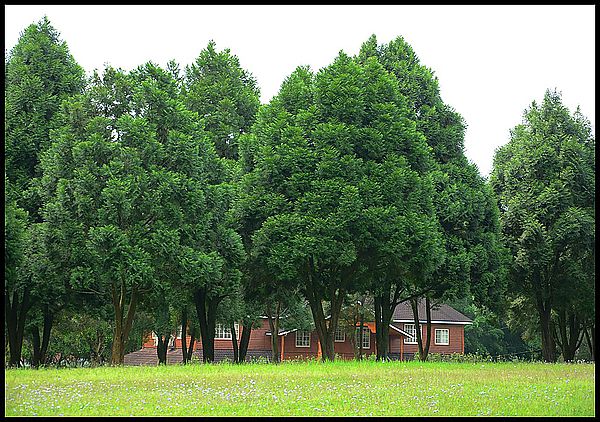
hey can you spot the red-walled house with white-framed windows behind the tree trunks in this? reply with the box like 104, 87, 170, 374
125, 301, 472, 365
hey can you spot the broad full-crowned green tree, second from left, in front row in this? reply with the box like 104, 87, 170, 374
38, 63, 225, 364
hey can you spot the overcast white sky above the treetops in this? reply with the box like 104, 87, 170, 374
4, 5, 596, 176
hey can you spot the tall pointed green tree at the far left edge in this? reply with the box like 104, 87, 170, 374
4, 17, 85, 365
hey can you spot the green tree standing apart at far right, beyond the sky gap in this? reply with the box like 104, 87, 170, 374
490, 90, 595, 362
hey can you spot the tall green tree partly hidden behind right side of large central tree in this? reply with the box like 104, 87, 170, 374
358, 35, 507, 359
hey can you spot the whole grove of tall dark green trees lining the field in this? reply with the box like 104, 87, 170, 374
4, 17, 595, 367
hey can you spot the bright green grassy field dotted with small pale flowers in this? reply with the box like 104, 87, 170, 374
4, 361, 596, 416
